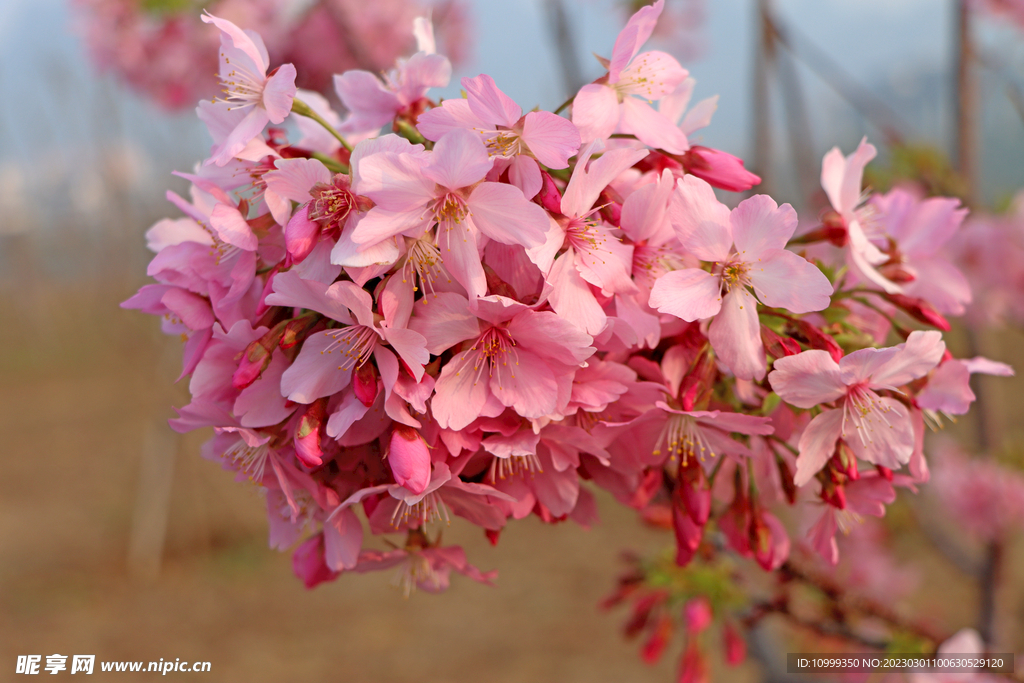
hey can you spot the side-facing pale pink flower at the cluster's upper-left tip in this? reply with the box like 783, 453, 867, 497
203, 14, 295, 166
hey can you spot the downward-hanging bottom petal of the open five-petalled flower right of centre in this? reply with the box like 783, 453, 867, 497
708, 287, 767, 381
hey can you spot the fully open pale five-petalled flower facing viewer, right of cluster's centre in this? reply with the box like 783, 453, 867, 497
650, 176, 833, 380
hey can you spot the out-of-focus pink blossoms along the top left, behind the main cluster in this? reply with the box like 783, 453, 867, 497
73, 0, 467, 110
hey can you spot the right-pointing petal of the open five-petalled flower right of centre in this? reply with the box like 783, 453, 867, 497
749, 249, 833, 313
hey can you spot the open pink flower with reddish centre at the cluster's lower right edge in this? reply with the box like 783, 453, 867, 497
768, 332, 946, 486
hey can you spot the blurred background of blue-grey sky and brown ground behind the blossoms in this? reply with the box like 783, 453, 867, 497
0, 0, 1024, 682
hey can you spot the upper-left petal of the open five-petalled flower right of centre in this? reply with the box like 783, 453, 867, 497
669, 174, 732, 262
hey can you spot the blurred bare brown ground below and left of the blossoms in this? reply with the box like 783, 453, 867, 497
0, 278, 1021, 683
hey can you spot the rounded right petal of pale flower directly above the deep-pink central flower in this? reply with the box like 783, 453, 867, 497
468, 182, 551, 248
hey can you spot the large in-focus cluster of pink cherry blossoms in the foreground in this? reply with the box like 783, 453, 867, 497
124, 0, 1008, 593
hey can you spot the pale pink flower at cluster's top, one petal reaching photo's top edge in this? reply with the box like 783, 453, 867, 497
572, 0, 689, 154
